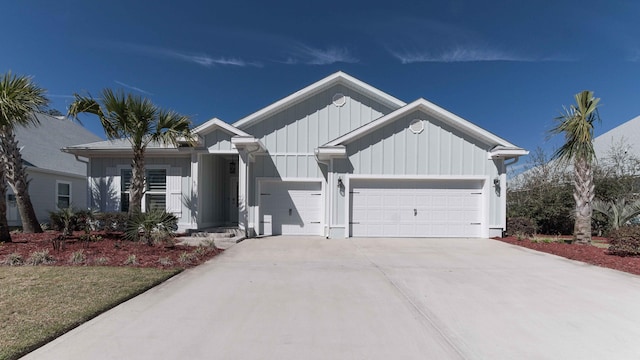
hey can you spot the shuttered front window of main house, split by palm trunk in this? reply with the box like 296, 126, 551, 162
120, 169, 167, 212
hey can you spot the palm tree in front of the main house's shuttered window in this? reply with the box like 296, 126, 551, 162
69, 89, 193, 217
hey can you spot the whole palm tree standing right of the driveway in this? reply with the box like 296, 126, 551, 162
549, 90, 600, 244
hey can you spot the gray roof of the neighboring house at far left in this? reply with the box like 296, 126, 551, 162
15, 114, 100, 176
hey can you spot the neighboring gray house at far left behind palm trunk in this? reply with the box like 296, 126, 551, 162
7, 114, 100, 226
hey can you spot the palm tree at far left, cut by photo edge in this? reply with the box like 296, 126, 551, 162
0, 72, 49, 233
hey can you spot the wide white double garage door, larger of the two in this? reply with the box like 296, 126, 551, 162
350, 179, 483, 237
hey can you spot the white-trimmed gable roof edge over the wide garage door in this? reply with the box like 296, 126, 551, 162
323, 98, 528, 156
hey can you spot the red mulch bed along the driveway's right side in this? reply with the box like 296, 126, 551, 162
495, 236, 640, 275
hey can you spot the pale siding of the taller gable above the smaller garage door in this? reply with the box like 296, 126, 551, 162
241, 84, 393, 236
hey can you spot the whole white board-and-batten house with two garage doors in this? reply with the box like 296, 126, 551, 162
65, 72, 528, 238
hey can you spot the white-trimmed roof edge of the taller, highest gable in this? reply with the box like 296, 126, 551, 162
233, 71, 406, 128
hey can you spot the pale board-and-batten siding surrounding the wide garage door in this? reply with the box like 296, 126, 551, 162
330, 111, 504, 232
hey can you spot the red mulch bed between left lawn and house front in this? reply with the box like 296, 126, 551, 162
0, 231, 223, 268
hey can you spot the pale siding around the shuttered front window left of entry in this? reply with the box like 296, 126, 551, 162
89, 155, 192, 224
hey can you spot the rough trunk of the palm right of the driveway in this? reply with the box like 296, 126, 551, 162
573, 159, 595, 245
